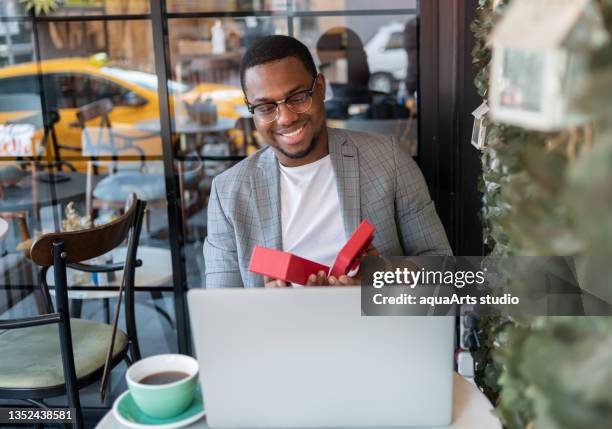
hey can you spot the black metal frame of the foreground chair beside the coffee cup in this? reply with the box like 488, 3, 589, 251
0, 200, 146, 428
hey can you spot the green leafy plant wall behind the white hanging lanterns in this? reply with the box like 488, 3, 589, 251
472, 0, 612, 429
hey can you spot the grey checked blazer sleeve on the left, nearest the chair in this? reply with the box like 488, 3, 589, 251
204, 180, 243, 288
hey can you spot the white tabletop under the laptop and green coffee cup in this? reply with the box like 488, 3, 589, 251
96, 374, 501, 429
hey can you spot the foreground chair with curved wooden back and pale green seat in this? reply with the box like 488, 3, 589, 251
0, 196, 145, 428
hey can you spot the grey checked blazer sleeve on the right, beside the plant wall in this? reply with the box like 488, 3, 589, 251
392, 141, 453, 256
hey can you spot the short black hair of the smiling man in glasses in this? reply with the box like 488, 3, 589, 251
240, 35, 317, 94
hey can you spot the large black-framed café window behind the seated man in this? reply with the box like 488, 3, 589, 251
0, 0, 420, 414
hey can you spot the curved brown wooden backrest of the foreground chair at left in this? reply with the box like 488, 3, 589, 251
30, 195, 138, 267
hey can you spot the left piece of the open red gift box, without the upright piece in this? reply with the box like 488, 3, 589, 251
249, 246, 329, 285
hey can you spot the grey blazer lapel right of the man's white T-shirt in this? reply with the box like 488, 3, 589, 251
328, 128, 361, 239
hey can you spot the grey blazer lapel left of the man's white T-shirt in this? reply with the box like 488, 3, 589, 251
251, 149, 282, 250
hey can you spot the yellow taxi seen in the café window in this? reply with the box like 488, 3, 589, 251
0, 58, 244, 160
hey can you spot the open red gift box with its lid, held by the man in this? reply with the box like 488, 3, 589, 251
249, 220, 375, 285
